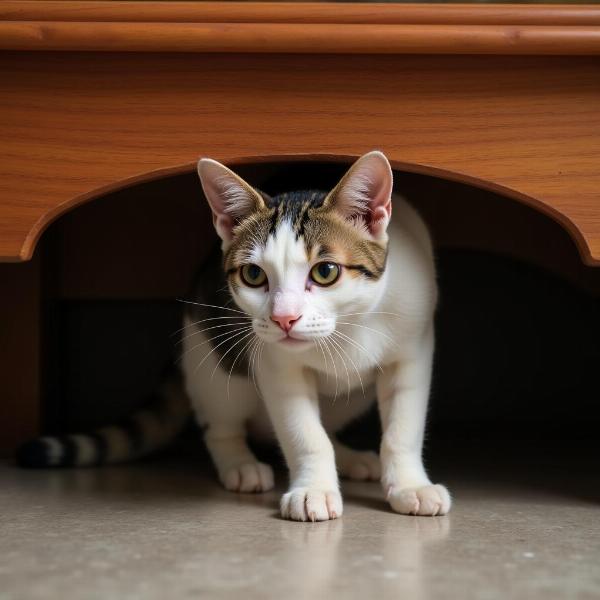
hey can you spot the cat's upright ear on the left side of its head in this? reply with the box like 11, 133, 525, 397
198, 158, 265, 242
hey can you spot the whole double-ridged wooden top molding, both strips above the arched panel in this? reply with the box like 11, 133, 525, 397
0, 0, 600, 55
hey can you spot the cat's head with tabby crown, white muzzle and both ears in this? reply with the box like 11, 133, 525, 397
198, 152, 393, 350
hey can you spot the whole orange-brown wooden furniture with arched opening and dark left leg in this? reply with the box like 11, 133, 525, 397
0, 0, 600, 449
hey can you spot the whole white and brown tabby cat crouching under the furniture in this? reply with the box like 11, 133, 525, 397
19, 151, 451, 521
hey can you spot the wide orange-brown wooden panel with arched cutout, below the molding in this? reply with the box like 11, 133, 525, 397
0, 53, 600, 264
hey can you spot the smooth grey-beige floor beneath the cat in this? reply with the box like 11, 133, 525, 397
0, 446, 600, 600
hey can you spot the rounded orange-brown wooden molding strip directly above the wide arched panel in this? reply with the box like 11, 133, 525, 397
0, 21, 600, 55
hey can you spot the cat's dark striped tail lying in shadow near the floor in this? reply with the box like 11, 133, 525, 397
17, 377, 190, 468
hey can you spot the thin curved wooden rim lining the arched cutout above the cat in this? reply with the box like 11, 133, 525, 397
19, 154, 600, 267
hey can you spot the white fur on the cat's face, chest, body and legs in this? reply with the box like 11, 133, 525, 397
188, 154, 450, 521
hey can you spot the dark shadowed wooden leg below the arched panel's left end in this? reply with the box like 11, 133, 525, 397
0, 255, 41, 456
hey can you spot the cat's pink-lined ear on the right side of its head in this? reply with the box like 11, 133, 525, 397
324, 150, 394, 238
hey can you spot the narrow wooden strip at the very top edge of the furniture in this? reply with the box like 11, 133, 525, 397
0, 0, 600, 26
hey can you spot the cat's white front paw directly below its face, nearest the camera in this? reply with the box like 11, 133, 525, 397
281, 487, 343, 522
